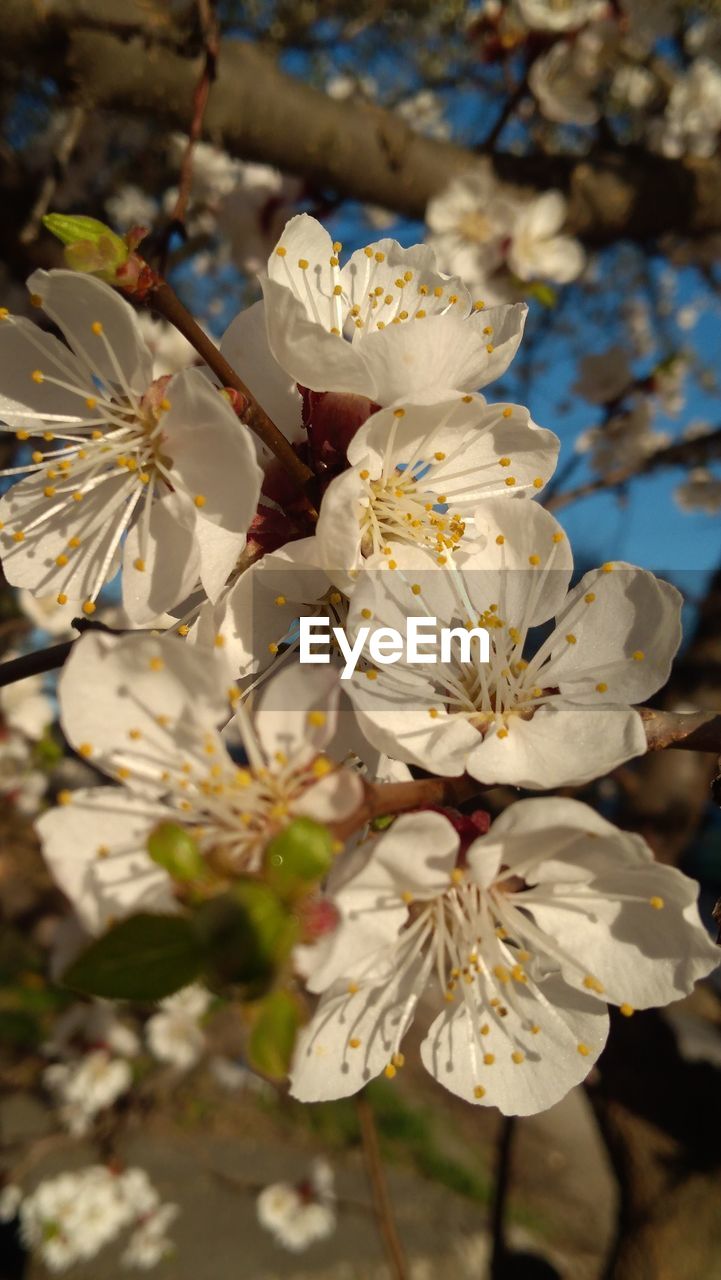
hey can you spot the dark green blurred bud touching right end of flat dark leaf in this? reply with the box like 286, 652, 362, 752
195, 878, 298, 997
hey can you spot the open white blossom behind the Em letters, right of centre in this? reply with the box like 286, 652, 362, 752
347, 498, 681, 787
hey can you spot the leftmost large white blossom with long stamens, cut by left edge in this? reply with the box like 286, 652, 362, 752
0, 271, 261, 622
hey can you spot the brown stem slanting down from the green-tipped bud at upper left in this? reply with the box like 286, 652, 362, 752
149, 279, 316, 506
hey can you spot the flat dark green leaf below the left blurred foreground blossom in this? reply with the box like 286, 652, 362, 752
63, 914, 202, 1000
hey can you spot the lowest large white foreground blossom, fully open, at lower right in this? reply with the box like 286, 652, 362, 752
291, 797, 718, 1115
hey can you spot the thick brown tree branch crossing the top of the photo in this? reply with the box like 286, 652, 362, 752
0, 0, 721, 243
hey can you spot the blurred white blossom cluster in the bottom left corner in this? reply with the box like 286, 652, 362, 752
0, 1165, 178, 1271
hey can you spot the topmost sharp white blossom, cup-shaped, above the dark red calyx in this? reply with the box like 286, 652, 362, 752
261, 214, 526, 404
